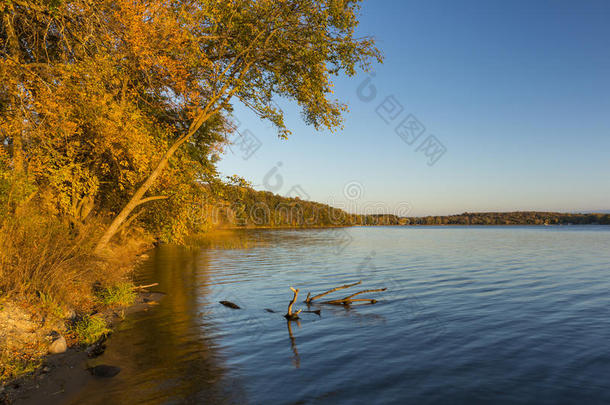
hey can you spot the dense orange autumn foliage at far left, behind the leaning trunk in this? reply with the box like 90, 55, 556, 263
0, 0, 228, 227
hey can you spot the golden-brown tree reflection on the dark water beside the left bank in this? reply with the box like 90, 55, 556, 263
69, 246, 243, 404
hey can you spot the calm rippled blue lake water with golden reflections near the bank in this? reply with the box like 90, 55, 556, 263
67, 226, 610, 404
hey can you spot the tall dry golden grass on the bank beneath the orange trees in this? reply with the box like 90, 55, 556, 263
0, 204, 147, 311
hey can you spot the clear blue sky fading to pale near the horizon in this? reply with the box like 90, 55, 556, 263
219, 0, 610, 216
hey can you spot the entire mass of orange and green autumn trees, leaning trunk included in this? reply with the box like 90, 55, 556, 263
0, 0, 381, 250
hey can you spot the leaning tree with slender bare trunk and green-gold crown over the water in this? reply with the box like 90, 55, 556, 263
91, 0, 379, 251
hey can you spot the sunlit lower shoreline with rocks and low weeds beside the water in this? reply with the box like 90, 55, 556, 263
0, 239, 159, 404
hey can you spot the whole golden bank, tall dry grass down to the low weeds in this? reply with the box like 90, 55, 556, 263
0, 204, 146, 383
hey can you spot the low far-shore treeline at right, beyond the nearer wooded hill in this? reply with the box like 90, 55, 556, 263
401, 211, 610, 225
